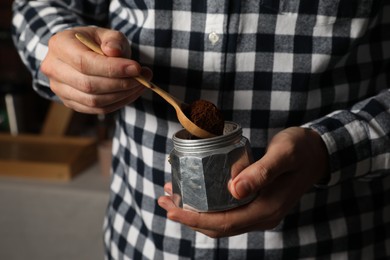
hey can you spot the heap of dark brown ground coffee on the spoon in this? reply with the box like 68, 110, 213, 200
184, 99, 225, 135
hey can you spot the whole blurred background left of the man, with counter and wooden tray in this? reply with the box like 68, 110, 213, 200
0, 0, 115, 260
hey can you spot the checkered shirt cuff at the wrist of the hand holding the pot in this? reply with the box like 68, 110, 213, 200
303, 110, 371, 188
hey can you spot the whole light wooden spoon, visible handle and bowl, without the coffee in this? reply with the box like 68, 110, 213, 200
75, 33, 215, 138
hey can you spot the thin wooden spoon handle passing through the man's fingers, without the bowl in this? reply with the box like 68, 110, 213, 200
75, 33, 185, 109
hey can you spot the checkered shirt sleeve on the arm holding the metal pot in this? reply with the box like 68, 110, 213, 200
306, 89, 390, 187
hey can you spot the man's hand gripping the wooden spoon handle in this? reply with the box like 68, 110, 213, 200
41, 27, 152, 114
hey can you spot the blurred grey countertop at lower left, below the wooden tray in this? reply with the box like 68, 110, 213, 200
0, 165, 109, 260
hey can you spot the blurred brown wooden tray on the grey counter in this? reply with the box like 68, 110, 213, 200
0, 134, 97, 181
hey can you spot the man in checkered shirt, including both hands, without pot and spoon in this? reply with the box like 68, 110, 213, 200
13, 0, 390, 259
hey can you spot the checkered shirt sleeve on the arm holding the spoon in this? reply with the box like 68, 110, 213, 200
12, 0, 109, 99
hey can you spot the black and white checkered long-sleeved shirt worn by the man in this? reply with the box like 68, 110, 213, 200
13, 0, 390, 259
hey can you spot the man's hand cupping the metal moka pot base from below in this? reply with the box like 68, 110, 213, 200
158, 127, 328, 238
